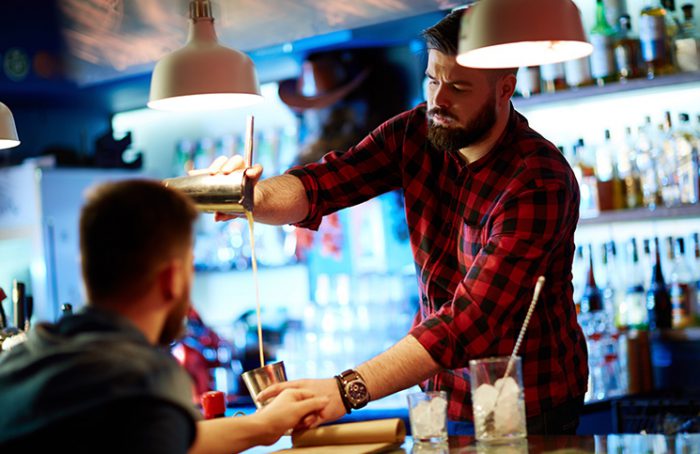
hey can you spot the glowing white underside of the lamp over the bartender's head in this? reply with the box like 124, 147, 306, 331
457, 41, 593, 68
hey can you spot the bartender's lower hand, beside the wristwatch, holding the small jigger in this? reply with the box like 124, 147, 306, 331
258, 378, 345, 427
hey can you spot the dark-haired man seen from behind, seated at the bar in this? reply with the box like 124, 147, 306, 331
0, 180, 328, 453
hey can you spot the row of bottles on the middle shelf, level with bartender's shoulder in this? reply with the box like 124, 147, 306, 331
559, 111, 700, 218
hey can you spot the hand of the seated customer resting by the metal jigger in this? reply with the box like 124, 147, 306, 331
251, 388, 329, 445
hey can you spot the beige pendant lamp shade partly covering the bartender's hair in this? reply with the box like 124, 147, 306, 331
457, 0, 593, 68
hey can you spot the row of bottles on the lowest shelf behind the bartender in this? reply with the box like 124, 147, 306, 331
573, 232, 700, 336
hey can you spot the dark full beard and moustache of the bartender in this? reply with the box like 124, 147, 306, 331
428, 94, 496, 152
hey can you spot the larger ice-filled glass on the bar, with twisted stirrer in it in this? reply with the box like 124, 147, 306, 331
469, 356, 527, 443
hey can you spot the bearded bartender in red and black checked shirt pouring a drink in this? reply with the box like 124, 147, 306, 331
209, 10, 588, 435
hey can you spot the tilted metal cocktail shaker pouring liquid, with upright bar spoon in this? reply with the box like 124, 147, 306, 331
163, 115, 255, 214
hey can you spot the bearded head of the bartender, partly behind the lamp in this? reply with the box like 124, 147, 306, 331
423, 9, 517, 150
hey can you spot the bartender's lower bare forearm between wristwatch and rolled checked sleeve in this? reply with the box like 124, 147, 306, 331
357, 335, 442, 400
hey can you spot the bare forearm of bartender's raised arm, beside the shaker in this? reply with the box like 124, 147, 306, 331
253, 175, 309, 225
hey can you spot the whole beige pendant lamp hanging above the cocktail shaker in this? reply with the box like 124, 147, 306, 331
148, 0, 262, 111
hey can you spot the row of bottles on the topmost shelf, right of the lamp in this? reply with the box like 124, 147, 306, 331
516, 0, 700, 97
